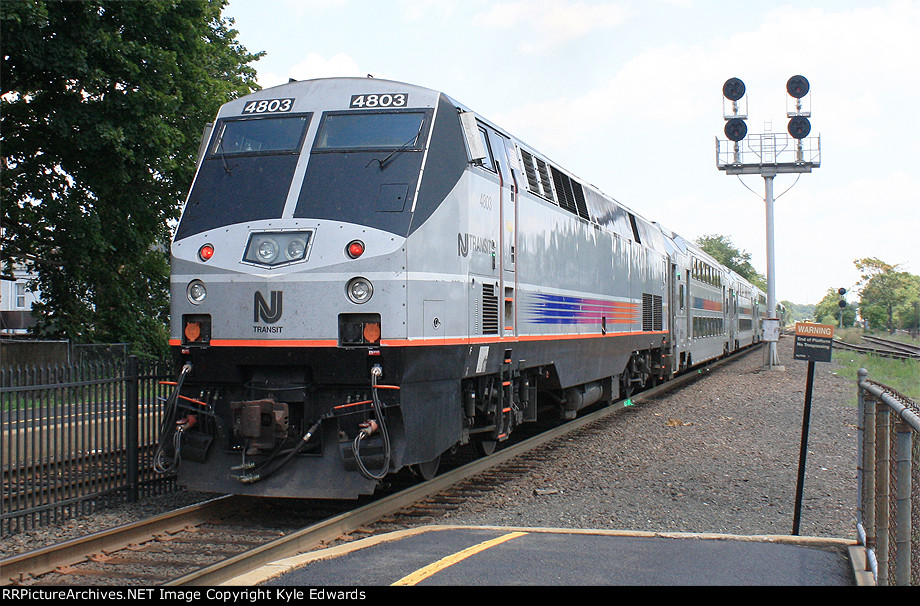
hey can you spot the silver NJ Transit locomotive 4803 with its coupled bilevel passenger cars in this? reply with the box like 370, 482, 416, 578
158, 78, 766, 498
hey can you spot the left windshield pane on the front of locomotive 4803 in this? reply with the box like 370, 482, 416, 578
211, 114, 310, 156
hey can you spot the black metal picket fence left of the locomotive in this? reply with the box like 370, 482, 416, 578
0, 356, 175, 536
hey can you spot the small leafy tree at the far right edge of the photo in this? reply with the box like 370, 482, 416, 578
853, 257, 920, 333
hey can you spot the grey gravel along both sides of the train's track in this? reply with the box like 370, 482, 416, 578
0, 337, 857, 556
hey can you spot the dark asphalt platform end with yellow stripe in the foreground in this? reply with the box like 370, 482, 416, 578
226, 525, 874, 588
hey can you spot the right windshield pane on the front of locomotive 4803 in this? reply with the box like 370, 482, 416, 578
314, 112, 427, 151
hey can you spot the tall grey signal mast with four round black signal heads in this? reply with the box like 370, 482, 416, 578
716, 76, 821, 368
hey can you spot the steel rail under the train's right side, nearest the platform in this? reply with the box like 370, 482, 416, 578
164, 347, 760, 586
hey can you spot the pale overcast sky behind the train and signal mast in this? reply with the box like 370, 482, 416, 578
224, 0, 920, 303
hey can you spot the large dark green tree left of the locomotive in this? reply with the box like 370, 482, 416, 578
0, 0, 261, 352
